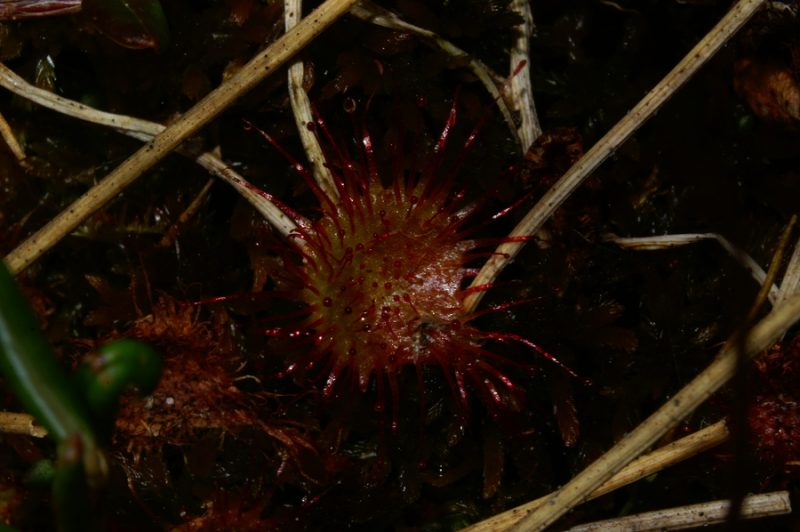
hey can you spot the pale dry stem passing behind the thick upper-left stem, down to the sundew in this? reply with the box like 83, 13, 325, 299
283, 0, 339, 198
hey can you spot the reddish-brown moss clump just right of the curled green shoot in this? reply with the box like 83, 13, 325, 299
105, 296, 316, 468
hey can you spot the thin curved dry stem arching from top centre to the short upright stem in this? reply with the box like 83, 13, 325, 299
350, 0, 528, 151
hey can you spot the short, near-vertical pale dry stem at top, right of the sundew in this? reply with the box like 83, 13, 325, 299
509, 0, 542, 151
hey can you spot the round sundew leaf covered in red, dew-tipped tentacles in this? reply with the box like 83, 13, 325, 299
253, 100, 560, 429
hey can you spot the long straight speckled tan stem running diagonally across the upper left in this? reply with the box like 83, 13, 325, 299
0, 0, 358, 272
